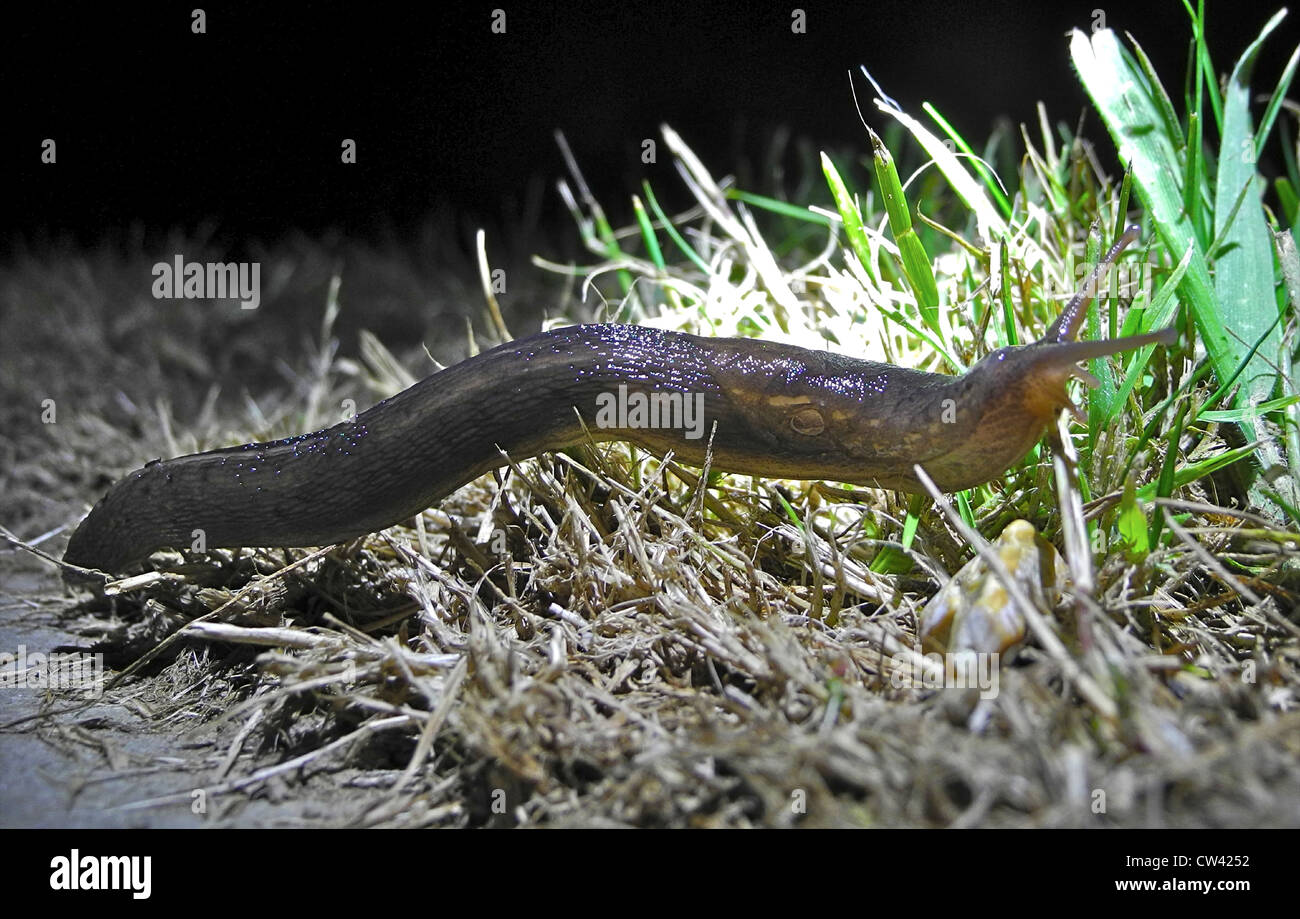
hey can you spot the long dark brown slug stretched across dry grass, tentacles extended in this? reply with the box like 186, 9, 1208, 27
64, 227, 1175, 577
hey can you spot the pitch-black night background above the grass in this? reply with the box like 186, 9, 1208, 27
0, 0, 1300, 247
